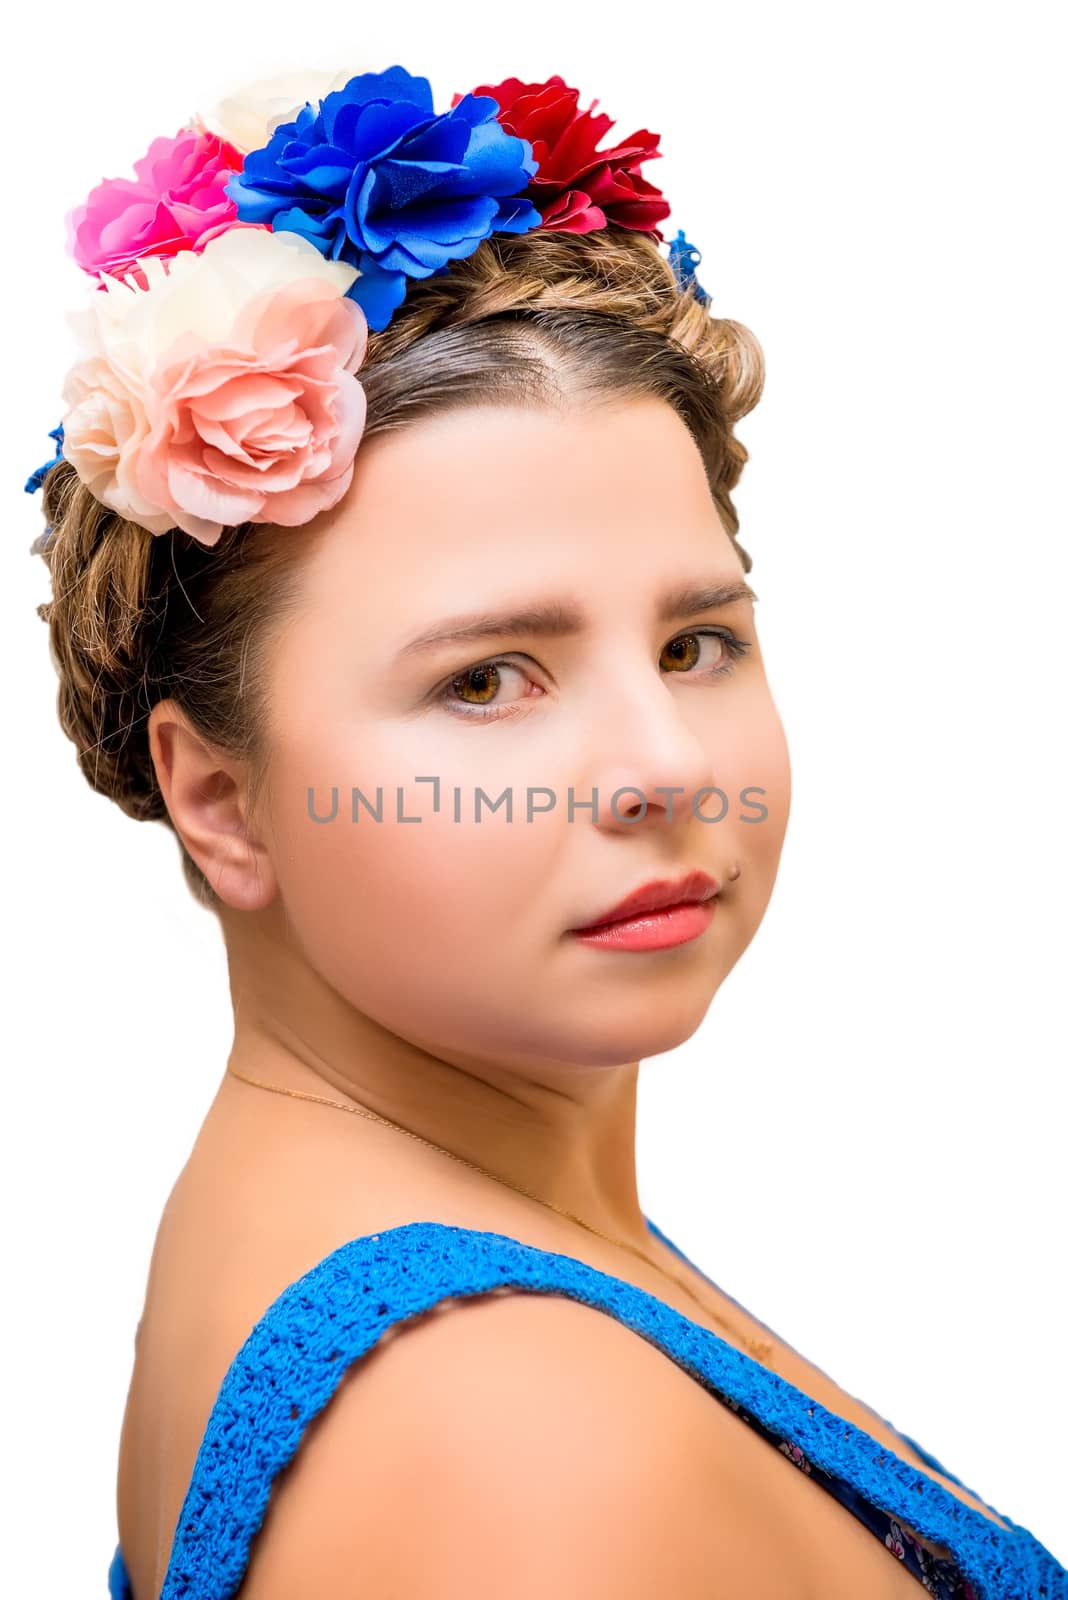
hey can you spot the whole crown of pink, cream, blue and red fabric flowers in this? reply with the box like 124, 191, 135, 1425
26, 66, 710, 550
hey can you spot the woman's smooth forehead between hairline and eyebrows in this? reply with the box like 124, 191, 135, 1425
292, 397, 740, 634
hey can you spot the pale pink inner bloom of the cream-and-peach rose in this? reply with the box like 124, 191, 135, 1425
131, 278, 368, 546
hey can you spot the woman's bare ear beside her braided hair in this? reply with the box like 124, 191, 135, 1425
149, 699, 278, 910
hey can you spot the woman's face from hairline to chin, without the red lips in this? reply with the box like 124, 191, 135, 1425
267, 400, 790, 1069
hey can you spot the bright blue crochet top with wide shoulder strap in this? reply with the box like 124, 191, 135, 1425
107, 1218, 1068, 1600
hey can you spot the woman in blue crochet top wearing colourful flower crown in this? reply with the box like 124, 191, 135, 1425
29, 67, 1068, 1600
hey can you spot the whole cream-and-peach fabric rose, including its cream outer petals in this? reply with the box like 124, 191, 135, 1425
64, 229, 368, 546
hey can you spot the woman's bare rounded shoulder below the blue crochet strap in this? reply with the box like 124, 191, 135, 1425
240, 1290, 791, 1600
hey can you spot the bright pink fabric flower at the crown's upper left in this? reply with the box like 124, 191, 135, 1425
67, 128, 251, 283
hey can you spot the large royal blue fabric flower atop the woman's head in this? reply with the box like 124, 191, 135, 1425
227, 66, 542, 331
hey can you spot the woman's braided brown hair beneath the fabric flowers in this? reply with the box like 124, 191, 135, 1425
37, 226, 764, 907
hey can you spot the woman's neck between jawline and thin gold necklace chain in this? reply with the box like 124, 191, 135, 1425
220, 908, 648, 1248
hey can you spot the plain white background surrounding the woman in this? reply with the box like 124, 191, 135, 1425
0, 0, 1068, 1595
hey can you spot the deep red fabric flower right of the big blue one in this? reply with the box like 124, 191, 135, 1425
452, 72, 671, 243
